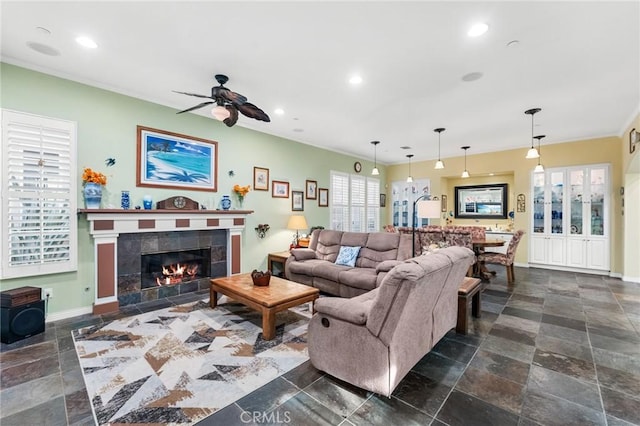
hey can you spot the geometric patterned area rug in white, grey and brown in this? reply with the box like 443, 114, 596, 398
73, 300, 309, 425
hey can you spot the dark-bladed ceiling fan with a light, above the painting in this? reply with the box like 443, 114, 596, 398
174, 74, 271, 127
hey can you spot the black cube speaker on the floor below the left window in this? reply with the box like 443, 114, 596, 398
0, 300, 44, 343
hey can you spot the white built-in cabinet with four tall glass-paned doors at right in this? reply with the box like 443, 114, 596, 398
529, 164, 610, 271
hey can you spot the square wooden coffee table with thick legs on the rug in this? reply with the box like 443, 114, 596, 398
209, 274, 320, 340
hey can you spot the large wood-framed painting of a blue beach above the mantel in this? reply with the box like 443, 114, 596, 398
136, 126, 218, 191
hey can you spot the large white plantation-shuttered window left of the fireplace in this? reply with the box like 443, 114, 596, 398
0, 110, 78, 278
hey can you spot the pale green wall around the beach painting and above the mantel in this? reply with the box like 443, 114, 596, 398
0, 63, 386, 313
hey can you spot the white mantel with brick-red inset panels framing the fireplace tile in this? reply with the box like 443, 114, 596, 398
78, 209, 253, 314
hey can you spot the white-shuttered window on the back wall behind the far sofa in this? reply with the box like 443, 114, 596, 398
330, 171, 380, 232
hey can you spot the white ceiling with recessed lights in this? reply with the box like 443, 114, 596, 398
1, 1, 640, 164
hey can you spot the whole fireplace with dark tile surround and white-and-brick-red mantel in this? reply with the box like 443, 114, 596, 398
80, 209, 253, 314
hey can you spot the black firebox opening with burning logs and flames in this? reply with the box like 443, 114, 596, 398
140, 248, 211, 288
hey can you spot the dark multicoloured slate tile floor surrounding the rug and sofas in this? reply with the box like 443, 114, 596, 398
0, 268, 640, 426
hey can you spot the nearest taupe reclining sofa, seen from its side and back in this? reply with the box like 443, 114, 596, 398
308, 247, 474, 396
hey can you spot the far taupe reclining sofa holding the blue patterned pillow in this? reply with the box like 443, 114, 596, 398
285, 229, 411, 297
